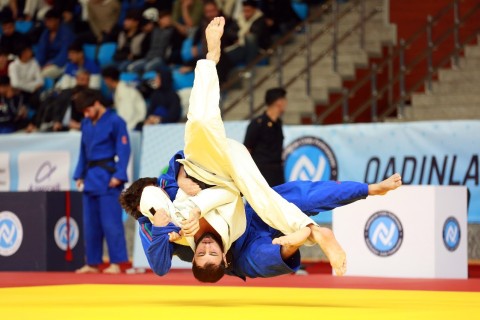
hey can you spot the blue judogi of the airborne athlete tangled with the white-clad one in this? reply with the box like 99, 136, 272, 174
138, 151, 368, 280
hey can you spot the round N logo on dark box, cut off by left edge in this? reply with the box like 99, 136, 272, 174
0, 211, 23, 256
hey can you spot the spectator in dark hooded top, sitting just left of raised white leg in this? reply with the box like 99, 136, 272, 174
139, 69, 182, 127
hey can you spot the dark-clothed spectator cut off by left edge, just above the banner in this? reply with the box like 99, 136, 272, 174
0, 76, 28, 134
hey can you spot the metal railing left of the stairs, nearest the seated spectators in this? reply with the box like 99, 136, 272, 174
221, 0, 379, 118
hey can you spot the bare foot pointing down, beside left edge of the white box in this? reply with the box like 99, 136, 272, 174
310, 225, 347, 276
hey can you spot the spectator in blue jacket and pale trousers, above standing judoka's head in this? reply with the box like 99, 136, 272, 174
55, 42, 101, 90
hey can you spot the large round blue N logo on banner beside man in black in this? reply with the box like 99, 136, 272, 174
283, 137, 338, 181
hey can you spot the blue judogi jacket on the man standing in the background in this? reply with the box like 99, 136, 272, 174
73, 109, 130, 194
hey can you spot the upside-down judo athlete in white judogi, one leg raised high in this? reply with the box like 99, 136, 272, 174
140, 17, 346, 275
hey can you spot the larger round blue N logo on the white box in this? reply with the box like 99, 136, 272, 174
365, 211, 403, 257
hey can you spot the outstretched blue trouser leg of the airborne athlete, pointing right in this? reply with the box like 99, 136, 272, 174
273, 181, 368, 214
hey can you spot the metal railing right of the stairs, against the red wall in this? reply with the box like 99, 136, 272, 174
316, 0, 480, 123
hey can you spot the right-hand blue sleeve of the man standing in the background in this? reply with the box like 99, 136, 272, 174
113, 118, 130, 182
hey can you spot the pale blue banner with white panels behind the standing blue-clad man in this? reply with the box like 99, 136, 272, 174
0, 132, 141, 191
